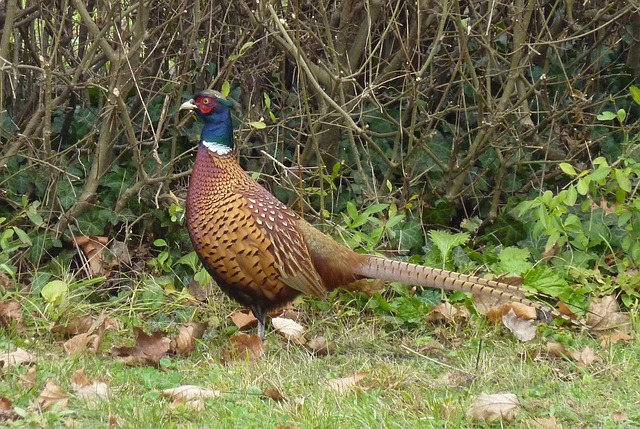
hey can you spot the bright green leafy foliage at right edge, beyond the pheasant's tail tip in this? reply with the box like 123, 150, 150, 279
513, 87, 640, 305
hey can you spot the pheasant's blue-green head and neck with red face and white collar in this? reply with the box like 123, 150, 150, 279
180, 90, 233, 155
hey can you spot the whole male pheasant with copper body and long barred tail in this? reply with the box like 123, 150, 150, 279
180, 90, 568, 339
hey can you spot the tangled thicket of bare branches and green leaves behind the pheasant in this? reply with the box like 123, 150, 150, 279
0, 0, 640, 320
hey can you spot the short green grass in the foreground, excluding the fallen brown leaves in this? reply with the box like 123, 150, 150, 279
0, 294, 640, 429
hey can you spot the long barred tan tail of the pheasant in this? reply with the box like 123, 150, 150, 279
354, 257, 582, 326
